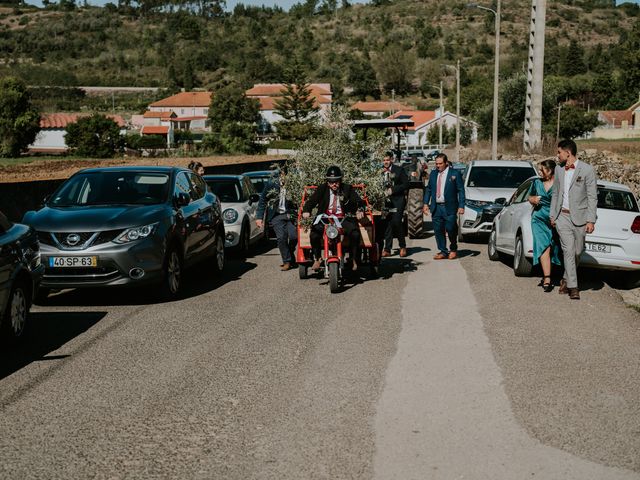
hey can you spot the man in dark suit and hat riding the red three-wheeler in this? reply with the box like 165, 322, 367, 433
302, 166, 364, 270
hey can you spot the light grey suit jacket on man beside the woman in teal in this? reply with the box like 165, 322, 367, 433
549, 162, 598, 226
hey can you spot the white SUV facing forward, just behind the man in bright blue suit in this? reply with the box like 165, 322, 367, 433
458, 160, 538, 241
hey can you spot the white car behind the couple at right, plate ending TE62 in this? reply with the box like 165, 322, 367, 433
487, 177, 640, 286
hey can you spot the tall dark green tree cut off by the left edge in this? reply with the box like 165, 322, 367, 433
0, 77, 40, 157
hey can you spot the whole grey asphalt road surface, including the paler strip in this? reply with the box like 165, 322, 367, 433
0, 231, 640, 480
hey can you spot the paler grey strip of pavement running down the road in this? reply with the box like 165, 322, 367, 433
374, 238, 640, 480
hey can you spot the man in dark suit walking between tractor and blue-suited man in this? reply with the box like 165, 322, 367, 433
382, 152, 409, 257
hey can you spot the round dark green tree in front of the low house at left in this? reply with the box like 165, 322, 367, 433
64, 114, 124, 158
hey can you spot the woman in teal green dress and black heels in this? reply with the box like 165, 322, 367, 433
529, 160, 561, 292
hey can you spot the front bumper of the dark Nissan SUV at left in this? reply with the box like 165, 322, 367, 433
40, 238, 165, 289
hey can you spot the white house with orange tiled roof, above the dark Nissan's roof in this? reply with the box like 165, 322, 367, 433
146, 92, 213, 135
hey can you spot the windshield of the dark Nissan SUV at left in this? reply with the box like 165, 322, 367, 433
49, 171, 169, 207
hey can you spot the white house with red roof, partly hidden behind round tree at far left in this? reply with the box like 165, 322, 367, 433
29, 113, 127, 153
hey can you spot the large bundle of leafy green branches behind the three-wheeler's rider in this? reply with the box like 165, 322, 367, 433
285, 107, 389, 209
